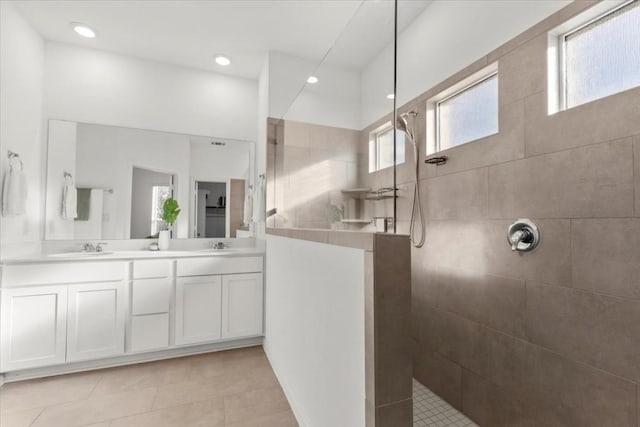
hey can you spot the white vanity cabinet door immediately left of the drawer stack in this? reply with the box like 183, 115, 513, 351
67, 282, 125, 362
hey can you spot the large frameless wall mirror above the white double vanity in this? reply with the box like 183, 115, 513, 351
45, 120, 255, 240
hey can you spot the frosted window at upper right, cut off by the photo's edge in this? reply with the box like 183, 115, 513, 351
550, 0, 640, 113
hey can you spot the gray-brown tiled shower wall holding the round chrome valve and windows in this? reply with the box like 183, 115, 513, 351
360, 2, 640, 427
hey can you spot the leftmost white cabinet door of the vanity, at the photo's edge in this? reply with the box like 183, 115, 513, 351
0, 286, 67, 372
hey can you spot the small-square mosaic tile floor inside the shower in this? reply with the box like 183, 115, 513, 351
413, 379, 477, 427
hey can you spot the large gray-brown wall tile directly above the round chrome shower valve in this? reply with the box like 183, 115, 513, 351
489, 138, 633, 218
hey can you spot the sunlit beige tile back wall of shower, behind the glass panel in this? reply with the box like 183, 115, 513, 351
267, 119, 362, 229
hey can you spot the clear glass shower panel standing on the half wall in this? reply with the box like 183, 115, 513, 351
267, 2, 394, 231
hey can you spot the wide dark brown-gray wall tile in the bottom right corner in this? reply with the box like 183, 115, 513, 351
489, 333, 636, 427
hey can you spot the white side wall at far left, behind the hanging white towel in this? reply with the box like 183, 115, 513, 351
0, 1, 44, 256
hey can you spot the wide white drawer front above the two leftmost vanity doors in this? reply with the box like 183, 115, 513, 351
2, 261, 127, 287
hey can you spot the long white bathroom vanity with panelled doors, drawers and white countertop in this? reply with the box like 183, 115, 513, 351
0, 248, 264, 379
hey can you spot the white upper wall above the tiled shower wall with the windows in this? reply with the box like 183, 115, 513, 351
361, 0, 570, 128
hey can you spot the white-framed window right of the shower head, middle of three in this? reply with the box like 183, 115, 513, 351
427, 64, 498, 154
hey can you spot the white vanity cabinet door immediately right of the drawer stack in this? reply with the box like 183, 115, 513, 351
176, 276, 222, 345
